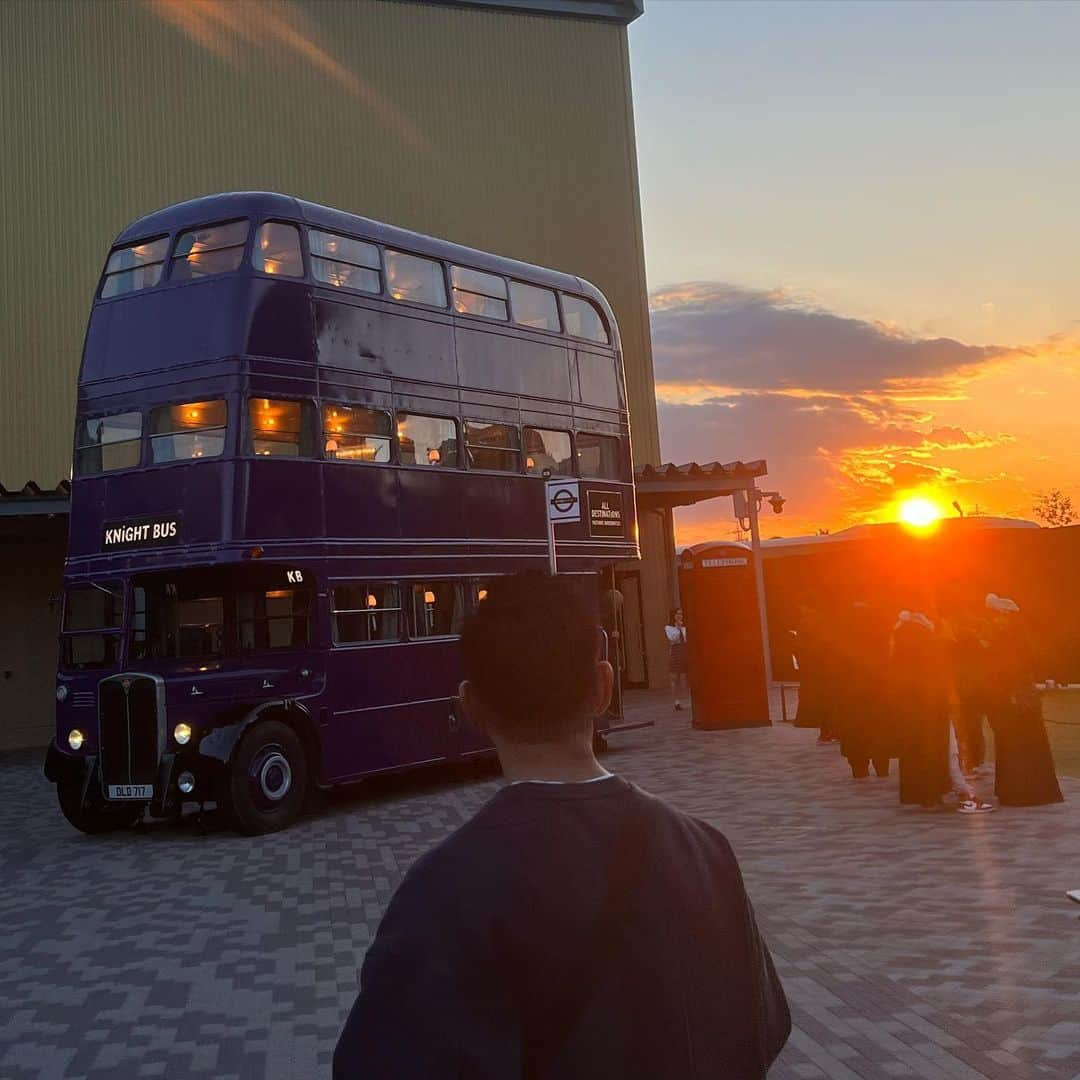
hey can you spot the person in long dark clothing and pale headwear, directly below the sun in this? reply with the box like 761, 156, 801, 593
890, 611, 953, 810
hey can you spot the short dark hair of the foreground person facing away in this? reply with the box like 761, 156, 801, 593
461, 573, 600, 742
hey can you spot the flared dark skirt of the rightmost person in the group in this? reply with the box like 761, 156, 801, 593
990, 701, 1064, 807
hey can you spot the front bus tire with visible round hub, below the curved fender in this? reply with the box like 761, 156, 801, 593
228, 720, 308, 836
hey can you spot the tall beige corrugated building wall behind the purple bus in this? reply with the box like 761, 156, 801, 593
0, 0, 666, 704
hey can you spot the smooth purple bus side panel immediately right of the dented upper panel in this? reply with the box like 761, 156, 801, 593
455, 326, 570, 401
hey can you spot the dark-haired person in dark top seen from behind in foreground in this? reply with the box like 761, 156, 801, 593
334, 577, 791, 1080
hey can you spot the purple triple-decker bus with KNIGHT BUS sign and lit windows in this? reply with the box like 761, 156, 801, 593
45, 192, 638, 834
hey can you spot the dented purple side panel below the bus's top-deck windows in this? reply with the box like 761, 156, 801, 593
314, 299, 458, 386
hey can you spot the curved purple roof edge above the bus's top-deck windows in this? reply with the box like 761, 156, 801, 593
113, 191, 616, 326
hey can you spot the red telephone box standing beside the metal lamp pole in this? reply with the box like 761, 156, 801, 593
678, 542, 772, 730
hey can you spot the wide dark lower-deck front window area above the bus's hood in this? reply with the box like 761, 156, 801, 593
131, 567, 312, 660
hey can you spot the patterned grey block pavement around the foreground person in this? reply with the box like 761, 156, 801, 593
0, 694, 1080, 1080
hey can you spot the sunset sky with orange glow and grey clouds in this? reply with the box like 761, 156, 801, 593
631, 0, 1080, 543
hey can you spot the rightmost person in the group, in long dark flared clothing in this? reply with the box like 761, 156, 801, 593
986, 593, 1063, 807
